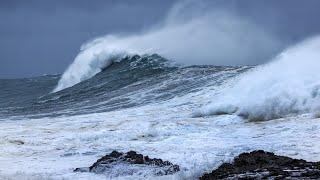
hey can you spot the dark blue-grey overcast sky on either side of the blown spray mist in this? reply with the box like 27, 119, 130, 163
0, 0, 320, 78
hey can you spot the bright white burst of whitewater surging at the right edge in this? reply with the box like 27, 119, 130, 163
196, 36, 320, 120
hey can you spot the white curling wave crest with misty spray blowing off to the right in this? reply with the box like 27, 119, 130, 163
54, 1, 283, 92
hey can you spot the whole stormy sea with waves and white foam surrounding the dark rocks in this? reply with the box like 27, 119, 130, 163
0, 37, 320, 179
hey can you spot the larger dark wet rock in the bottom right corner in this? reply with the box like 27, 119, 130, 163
200, 150, 320, 180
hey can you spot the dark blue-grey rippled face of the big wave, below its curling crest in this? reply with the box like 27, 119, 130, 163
0, 54, 248, 118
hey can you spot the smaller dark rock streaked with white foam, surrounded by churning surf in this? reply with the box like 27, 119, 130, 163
74, 151, 180, 177
